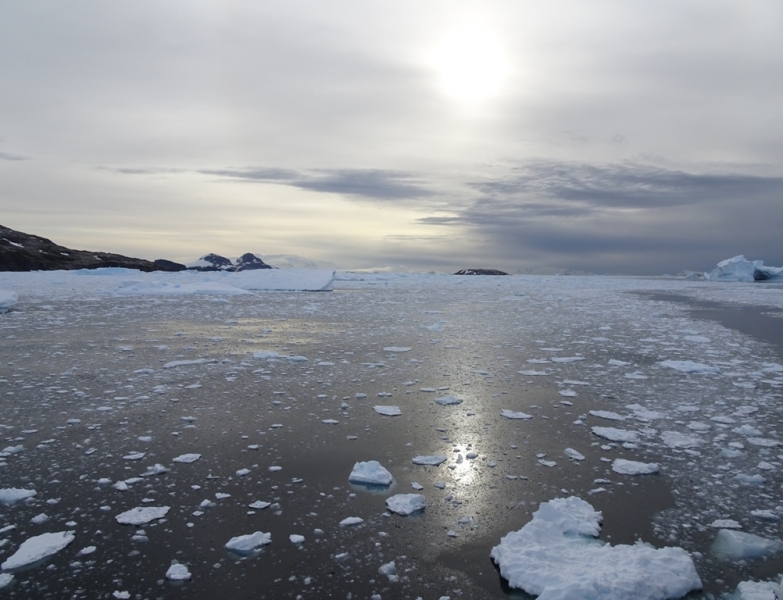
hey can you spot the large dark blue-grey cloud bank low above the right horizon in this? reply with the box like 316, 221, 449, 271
419, 162, 783, 274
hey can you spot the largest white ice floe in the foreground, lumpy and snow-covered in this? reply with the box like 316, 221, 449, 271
490, 496, 702, 600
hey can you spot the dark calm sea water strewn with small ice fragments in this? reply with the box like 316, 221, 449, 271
0, 276, 783, 599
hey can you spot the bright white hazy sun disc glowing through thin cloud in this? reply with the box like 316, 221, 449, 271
430, 28, 510, 103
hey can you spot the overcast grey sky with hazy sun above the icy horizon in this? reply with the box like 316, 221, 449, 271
0, 0, 783, 275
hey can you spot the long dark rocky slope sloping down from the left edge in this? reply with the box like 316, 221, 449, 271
0, 225, 185, 271
